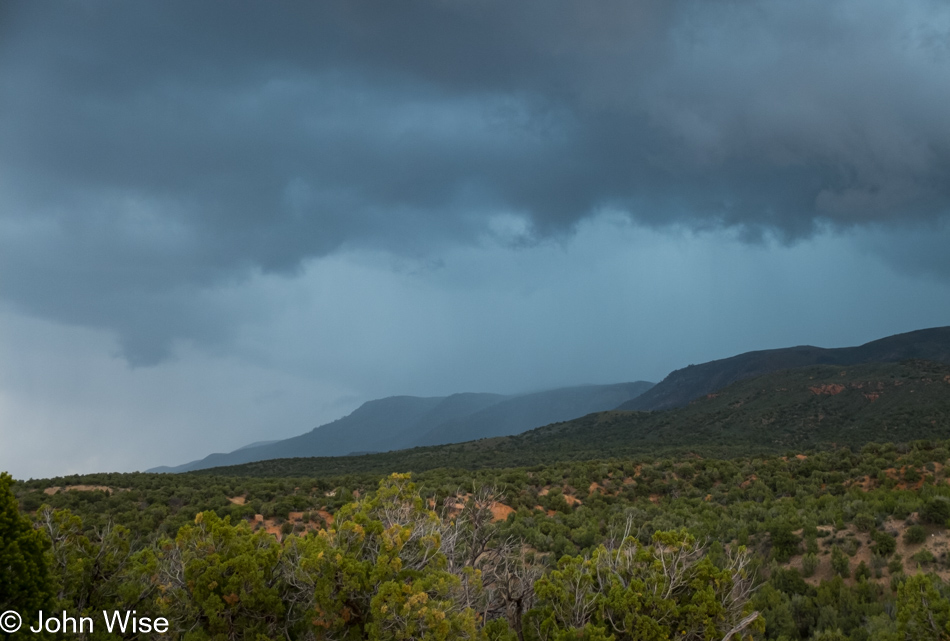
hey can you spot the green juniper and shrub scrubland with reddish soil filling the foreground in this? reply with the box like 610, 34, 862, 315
13, 441, 950, 641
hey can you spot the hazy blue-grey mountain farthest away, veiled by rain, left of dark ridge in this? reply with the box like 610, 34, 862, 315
148, 381, 653, 472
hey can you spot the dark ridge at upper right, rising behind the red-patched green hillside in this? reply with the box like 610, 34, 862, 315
616, 327, 950, 411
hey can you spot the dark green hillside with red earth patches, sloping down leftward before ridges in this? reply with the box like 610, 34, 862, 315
197, 360, 950, 476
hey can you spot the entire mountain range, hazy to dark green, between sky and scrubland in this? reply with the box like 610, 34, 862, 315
156, 327, 950, 475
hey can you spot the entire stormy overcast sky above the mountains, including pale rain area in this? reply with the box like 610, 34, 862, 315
0, 0, 950, 478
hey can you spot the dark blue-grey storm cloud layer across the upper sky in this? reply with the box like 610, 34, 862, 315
0, 0, 950, 364
